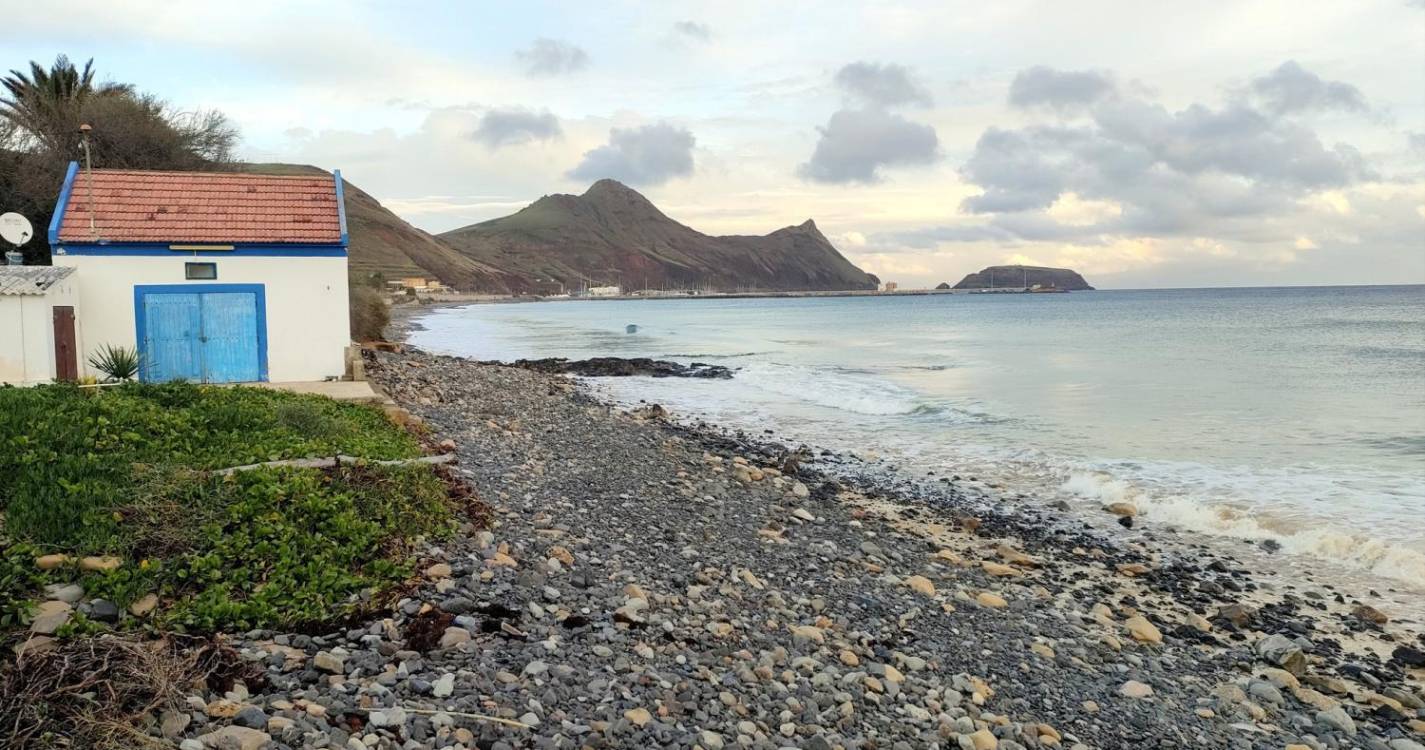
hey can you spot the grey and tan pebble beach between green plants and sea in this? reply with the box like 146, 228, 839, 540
161, 343, 1425, 750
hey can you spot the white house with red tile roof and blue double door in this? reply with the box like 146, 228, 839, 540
50, 164, 351, 382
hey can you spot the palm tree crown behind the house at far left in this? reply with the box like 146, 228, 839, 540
0, 54, 134, 154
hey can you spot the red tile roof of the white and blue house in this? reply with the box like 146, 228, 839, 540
60, 170, 342, 244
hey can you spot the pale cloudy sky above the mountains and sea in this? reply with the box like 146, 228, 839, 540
0, 0, 1425, 288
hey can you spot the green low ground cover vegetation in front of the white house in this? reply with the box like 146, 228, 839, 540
0, 384, 457, 637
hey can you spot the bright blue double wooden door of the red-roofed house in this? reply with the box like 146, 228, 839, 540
135, 284, 266, 382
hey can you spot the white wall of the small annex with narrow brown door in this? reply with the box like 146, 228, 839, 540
0, 274, 86, 385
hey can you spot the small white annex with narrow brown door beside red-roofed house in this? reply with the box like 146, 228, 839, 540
0, 265, 80, 385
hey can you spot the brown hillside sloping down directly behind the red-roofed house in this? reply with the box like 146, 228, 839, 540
242, 164, 529, 294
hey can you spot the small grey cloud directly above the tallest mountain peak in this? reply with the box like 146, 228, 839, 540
569, 123, 697, 185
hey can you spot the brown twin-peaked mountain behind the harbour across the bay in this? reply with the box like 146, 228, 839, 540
437, 180, 879, 291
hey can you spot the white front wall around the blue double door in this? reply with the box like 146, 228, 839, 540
54, 252, 352, 382
